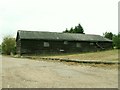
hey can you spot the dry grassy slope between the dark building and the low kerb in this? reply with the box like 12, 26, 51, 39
34, 49, 118, 61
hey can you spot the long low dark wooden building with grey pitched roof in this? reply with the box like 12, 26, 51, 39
16, 30, 112, 55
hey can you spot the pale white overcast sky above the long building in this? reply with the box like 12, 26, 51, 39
0, 0, 119, 43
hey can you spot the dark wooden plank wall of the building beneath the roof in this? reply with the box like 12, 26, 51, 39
17, 39, 112, 54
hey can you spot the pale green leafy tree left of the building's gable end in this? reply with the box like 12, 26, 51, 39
2, 36, 16, 55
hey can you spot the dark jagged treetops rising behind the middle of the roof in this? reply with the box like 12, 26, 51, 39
63, 24, 84, 34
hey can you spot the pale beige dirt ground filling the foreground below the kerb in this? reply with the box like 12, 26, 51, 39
0, 56, 118, 88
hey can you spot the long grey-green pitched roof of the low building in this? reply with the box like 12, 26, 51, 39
16, 30, 112, 42
